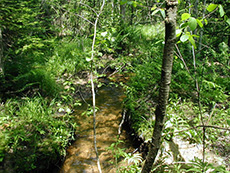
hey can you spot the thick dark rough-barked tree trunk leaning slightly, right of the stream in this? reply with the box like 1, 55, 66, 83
142, 0, 178, 173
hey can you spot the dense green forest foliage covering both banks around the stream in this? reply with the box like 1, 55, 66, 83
0, 0, 230, 172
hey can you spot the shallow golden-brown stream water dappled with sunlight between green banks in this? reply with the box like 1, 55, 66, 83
60, 87, 132, 173
